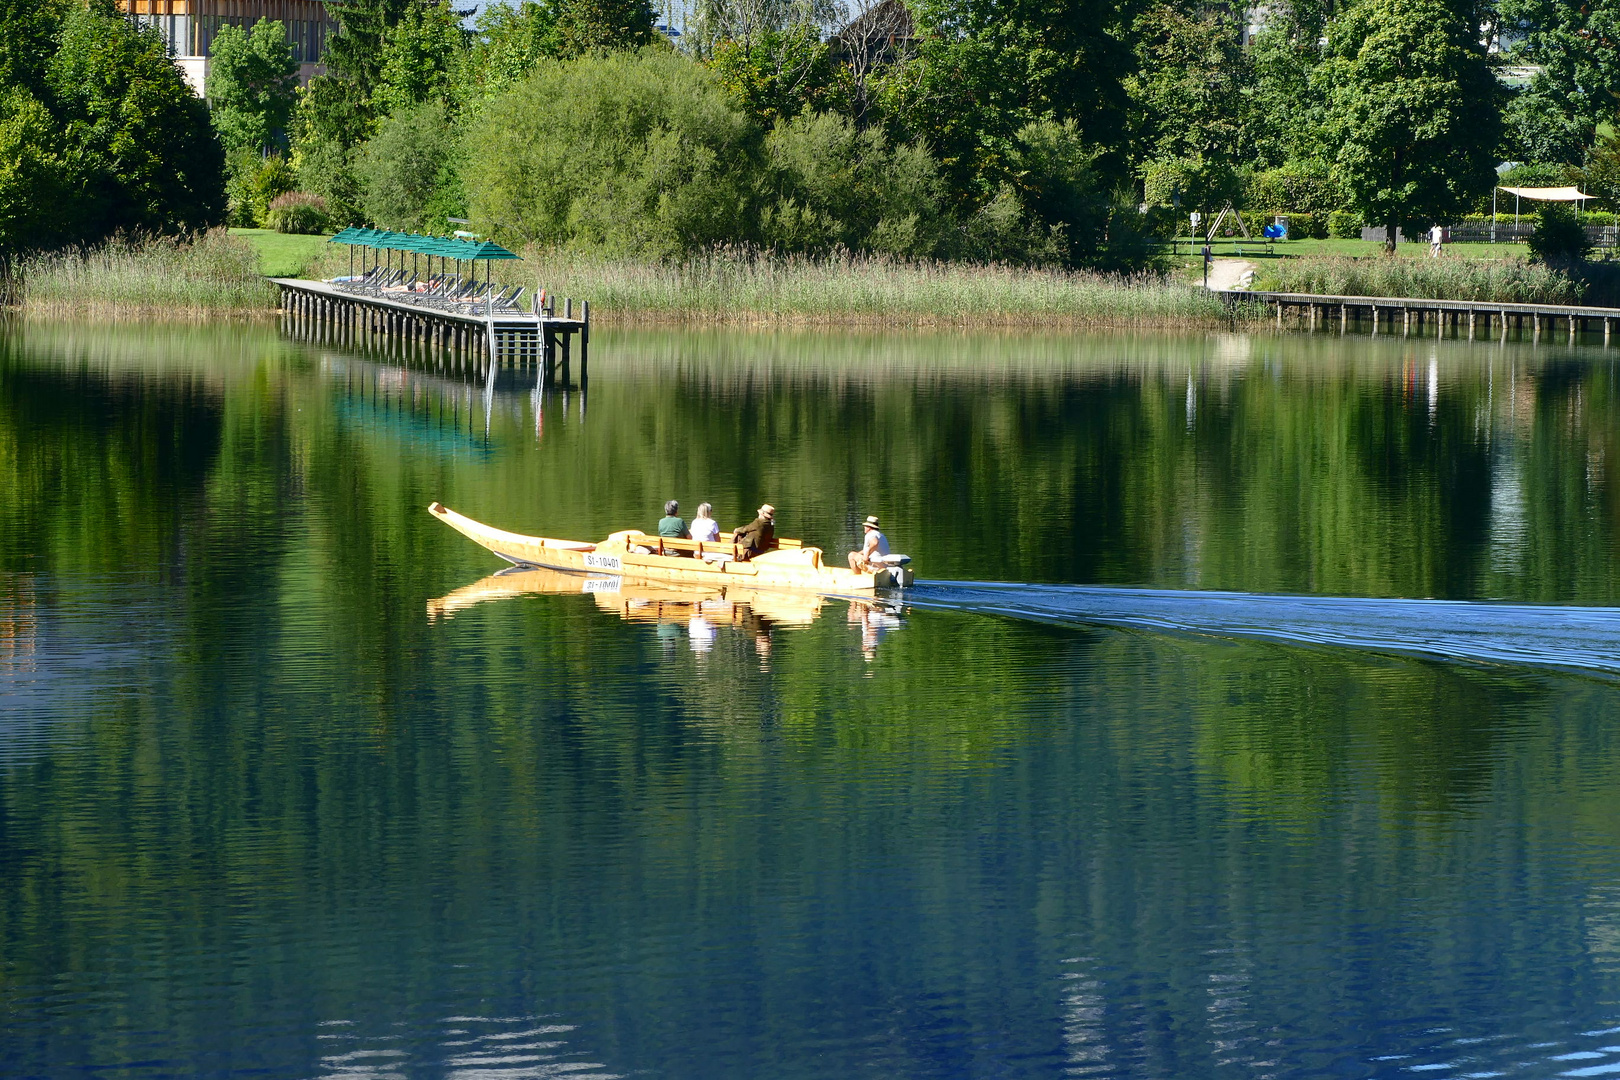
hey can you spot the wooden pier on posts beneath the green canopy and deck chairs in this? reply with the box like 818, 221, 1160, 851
271, 277, 591, 382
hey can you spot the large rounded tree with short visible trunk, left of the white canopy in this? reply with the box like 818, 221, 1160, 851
1328, 0, 1502, 251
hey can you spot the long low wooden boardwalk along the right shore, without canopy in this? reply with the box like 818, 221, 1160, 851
1223, 290, 1620, 345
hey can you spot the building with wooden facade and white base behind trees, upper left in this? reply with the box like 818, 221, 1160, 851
118, 0, 337, 96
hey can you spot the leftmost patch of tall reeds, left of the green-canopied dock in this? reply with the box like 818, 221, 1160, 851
11, 228, 275, 316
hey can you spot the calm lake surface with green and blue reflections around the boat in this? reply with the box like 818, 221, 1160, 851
0, 324, 1620, 1080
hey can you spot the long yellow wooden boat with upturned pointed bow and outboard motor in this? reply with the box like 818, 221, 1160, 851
428, 502, 912, 594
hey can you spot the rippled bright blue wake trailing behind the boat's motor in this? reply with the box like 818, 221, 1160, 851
906, 581, 1620, 675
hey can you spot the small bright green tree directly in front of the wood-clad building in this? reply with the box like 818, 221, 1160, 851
207, 19, 298, 154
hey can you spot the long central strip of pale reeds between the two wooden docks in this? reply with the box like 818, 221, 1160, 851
512, 249, 1233, 327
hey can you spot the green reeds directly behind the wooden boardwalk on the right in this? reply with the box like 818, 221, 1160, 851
1256, 256, 1584, 304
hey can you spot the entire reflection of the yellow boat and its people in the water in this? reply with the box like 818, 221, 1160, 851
428, 567, 901, 661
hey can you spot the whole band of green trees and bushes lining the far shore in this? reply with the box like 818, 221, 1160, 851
0, 0, 1620, 269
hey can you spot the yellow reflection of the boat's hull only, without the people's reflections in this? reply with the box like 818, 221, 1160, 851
428, 567, 825, 627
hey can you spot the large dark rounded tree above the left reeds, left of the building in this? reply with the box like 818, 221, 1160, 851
47, 0, 225, 236
